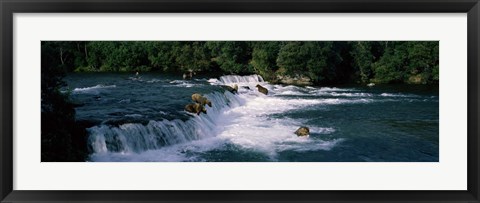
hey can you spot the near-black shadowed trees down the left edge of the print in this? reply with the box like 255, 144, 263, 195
41, 42, 87, 162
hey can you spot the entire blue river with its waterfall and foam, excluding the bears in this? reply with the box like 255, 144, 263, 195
66, 73, 439, 162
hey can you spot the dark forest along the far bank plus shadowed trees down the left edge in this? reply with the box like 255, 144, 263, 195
41, 41, 439, 161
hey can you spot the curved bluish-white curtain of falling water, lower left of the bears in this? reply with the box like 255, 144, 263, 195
87, 91, 244, 153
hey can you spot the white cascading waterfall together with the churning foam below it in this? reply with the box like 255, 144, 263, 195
87, 75, 346, 161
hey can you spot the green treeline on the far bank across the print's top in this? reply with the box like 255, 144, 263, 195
42, 41, 439, 84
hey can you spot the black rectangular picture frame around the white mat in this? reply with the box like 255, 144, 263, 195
0, 0, 480, 202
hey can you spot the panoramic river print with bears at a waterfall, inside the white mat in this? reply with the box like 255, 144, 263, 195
41, 41, 439, 162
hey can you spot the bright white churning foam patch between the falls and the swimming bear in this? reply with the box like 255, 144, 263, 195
212, 100, 336, 160
